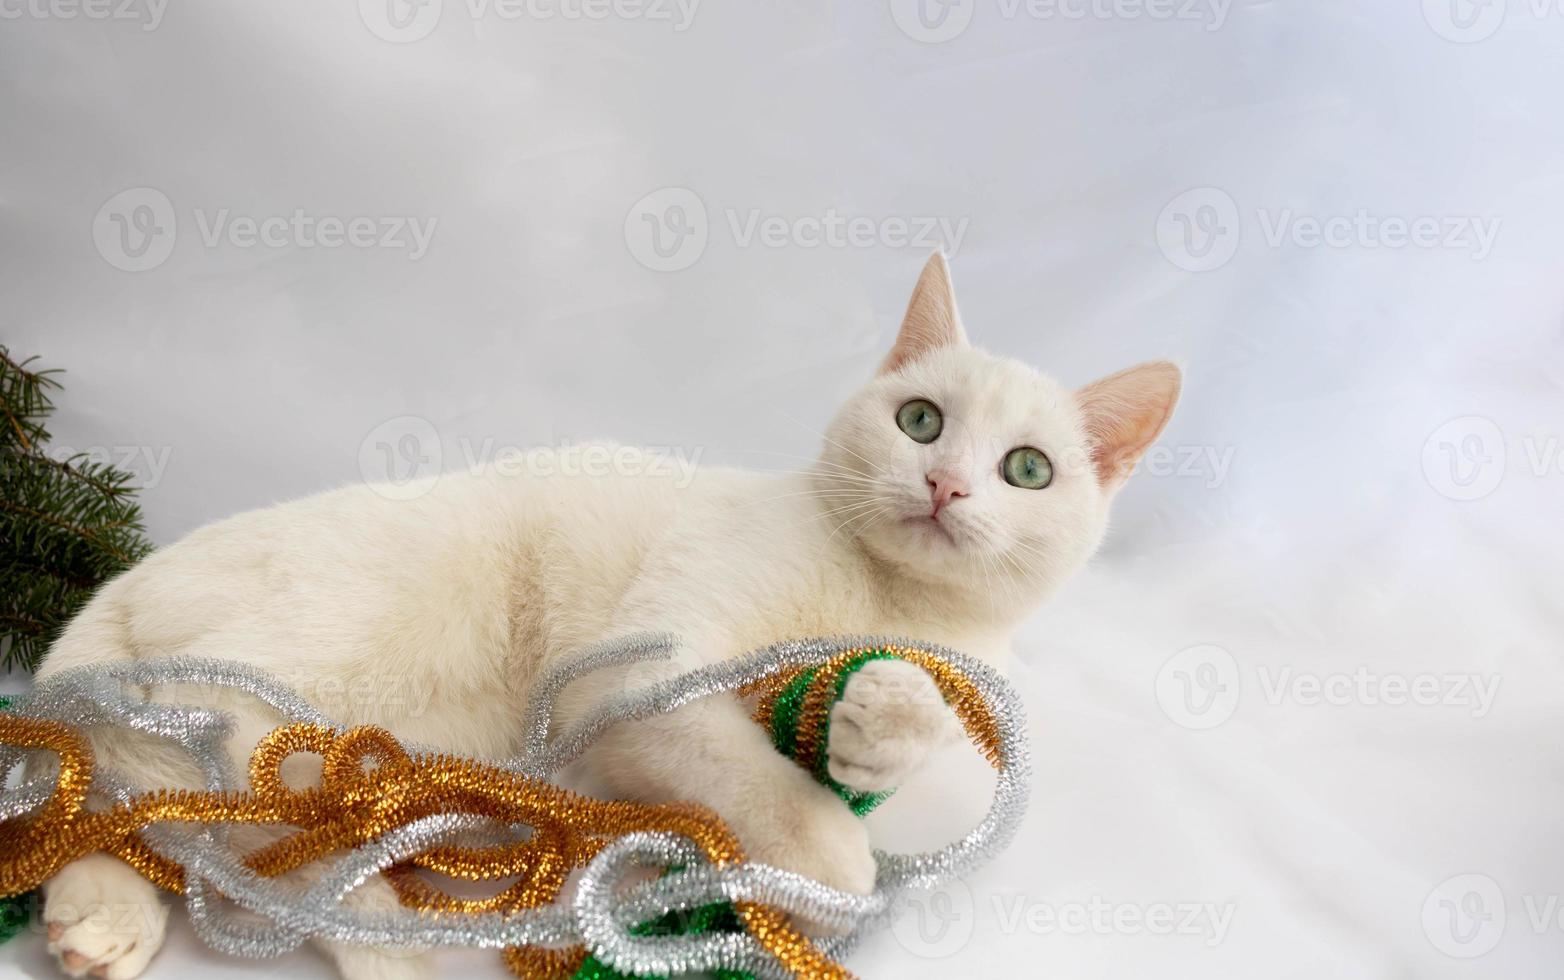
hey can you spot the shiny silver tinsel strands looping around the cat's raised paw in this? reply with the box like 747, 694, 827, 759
0, 635, 1031, 977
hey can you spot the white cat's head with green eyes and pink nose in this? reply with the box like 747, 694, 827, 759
818, 255, 1182, 611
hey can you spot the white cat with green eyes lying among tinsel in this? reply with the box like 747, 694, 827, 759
30, 255, 1181, 980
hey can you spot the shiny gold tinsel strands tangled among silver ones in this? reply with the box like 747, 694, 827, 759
0, 647, 999, 978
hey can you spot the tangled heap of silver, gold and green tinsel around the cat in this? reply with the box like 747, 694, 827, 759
0, 636, 1028, 977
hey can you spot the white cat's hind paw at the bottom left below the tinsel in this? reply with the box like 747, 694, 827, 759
44, 853, 169, 980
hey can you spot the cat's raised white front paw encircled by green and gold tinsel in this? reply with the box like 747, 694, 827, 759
826, 660, 960, 792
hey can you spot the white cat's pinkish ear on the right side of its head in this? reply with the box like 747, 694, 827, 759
1076, 361, 1184, 492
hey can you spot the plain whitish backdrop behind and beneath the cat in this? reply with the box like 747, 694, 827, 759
0, 0, 1564, 980
